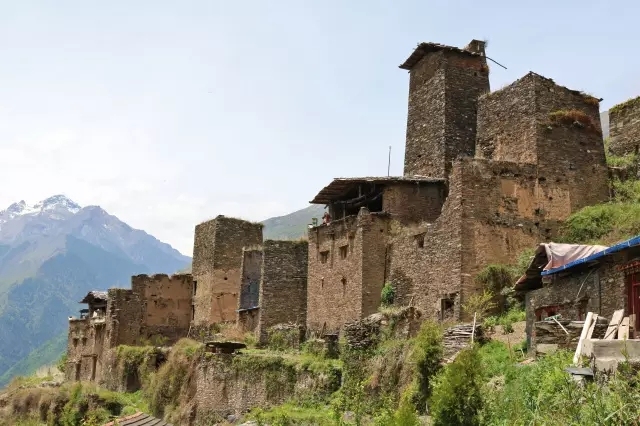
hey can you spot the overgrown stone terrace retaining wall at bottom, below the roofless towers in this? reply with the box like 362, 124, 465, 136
194, 354, 340, 424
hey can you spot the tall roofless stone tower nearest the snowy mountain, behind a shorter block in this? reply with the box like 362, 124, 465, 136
193, 216, 262, 325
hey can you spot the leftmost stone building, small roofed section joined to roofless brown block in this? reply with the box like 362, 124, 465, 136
65, 274, 193, 381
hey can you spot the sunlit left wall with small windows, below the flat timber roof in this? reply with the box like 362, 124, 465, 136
307, 216, 363, 331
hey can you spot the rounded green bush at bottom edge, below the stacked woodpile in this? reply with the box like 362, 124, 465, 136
430, 347, 482, 426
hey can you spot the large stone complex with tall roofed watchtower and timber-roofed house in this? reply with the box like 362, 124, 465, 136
307, 40, 609, 331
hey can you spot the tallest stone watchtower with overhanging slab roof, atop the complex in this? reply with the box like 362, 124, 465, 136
400, 40, 489, 178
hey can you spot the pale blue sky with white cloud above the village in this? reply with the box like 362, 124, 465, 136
0, 0, 640, 255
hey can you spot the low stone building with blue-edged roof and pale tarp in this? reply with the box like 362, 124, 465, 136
515, 236, 640, 347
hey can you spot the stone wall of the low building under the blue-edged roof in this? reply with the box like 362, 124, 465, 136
525, 256, 628, 346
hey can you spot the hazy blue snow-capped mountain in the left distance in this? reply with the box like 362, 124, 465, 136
0, 195, 191, 386
